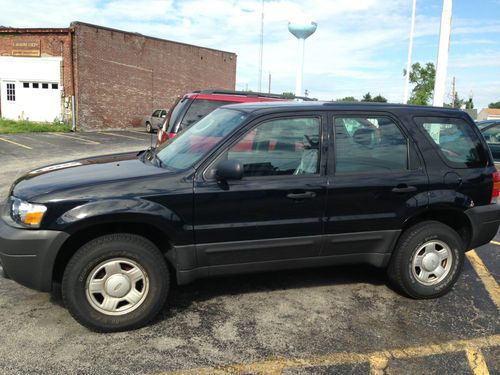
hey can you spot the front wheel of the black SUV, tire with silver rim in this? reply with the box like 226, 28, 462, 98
62, 233, 170, 332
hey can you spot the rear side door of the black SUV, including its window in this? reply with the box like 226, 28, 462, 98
322, 113, 428, 263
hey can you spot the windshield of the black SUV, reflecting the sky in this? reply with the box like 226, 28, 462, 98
157, 109, 248, 170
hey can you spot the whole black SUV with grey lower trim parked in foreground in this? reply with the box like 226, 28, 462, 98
0, 102, 500, 331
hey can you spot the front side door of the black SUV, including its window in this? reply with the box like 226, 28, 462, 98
194, 113, 327, 270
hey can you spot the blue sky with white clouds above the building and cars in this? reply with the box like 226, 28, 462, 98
0, 0, 500, 108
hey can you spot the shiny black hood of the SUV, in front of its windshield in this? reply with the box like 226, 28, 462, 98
11, 152, 169, 201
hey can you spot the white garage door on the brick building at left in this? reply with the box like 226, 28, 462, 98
0, 57, 61, 122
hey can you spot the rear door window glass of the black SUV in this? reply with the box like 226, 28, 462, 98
334, 116, 408, 174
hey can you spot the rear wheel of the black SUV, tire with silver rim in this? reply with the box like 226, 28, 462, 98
387, 221, 465, 299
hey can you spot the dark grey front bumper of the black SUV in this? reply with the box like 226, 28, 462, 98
0, 214, 69, 292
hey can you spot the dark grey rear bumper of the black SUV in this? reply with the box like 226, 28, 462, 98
465, 204, 500, 249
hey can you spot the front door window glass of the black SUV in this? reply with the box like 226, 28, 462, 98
218, 117, 321, 177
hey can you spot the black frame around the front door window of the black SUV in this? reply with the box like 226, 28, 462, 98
196, 111, 328, 182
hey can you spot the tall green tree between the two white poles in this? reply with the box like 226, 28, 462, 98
404, 62, 436, 105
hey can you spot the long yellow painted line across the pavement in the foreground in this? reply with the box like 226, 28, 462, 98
161, 335, 500, 375
